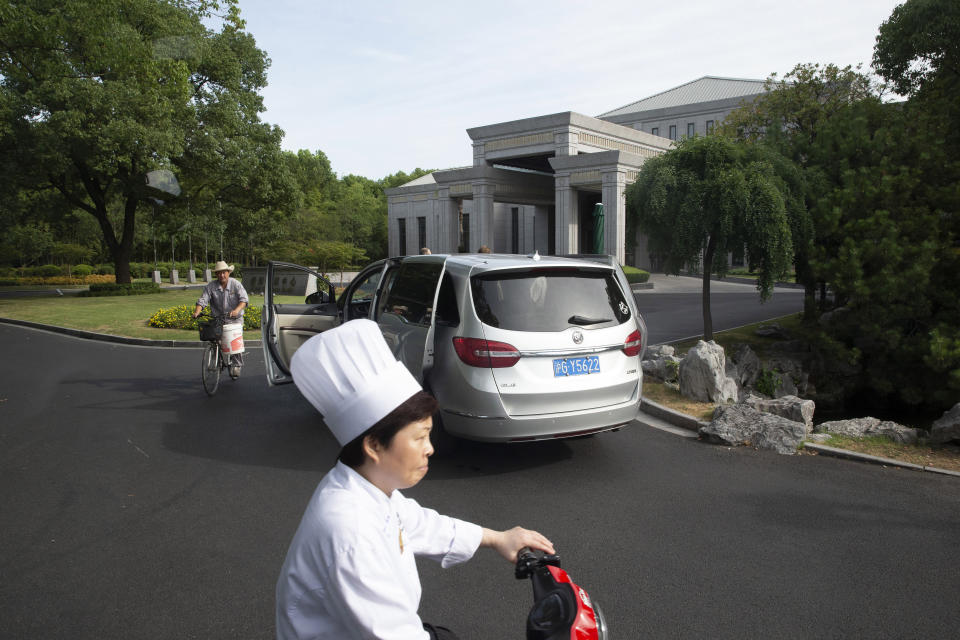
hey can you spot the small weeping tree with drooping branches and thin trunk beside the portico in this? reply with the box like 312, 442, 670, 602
626, 136, 796, 340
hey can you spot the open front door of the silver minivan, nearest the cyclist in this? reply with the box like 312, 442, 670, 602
261, 261, 337, 384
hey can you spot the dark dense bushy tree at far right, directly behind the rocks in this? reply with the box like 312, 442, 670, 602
811, 100, 960, 408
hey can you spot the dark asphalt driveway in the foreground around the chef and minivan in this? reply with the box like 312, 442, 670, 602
0, 288, 960, 640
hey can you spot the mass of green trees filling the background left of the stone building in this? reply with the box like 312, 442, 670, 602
0, 0, 424, 282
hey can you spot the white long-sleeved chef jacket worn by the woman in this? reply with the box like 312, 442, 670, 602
277, 462, 483, 640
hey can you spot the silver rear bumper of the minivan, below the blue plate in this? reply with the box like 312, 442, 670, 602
441, 379, 643, 442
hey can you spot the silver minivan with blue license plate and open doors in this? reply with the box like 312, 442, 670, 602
263, 254, 647, 442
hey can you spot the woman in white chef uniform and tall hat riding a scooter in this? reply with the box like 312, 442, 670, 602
277, 320, 554, 640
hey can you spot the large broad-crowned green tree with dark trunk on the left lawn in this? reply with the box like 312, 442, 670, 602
0, 0, 292, 282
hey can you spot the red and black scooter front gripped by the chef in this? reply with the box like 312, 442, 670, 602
515, 548, 610, 640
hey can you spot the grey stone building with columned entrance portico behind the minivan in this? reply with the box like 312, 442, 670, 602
387, 76, 763, 269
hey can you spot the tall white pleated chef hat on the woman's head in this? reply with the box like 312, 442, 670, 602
290, 320, 422, 446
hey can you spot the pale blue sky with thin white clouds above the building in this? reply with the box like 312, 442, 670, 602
240, 0, 900, 179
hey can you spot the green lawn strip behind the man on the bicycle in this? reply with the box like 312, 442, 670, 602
0, 289, 303, 340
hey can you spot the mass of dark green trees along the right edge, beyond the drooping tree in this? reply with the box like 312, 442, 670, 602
723, 0, 960, 410
